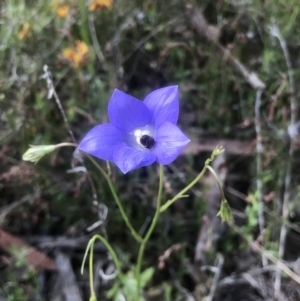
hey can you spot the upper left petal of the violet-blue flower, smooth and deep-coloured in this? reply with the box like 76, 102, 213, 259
108, 90, 152, 132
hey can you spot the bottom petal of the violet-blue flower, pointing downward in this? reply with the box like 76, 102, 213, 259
114, 145, 156, 173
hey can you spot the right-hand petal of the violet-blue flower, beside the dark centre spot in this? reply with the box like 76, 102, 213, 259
153, 122, 190, 165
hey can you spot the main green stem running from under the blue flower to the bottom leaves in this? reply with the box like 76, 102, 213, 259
136, 165, 164, 300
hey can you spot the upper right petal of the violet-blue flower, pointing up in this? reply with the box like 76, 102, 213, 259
144, 86, 179, 126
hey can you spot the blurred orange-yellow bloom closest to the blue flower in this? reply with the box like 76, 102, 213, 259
63, 41, 89, 68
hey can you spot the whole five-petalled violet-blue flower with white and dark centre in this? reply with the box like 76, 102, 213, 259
78, 86, 190, 173
